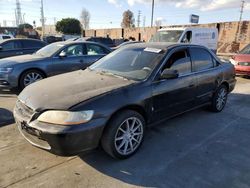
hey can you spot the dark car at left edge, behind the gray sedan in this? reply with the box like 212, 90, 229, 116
0, 39, 46, 59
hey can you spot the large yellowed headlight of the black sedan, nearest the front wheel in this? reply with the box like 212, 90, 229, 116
37, 110, 94, 125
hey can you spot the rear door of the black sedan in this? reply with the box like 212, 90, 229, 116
190, 47, 223, 105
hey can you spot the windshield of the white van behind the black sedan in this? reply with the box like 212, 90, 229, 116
150, 30, 183, 42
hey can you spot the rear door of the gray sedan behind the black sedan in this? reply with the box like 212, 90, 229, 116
84, 43, 109, 66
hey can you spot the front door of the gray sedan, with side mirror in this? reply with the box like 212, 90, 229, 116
50, 44, 87, 75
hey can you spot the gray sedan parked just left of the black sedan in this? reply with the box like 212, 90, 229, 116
0, 41, 111, 89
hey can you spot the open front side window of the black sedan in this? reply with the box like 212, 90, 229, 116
166, 50, 192, 75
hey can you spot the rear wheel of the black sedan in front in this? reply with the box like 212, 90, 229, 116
211, 85, 228, 112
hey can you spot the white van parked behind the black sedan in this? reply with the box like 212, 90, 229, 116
149, 27, 218, 52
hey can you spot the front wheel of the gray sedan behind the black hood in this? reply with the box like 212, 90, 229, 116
19, 70, 45, 90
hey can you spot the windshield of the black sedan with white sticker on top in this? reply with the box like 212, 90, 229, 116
90, 48, 164, 80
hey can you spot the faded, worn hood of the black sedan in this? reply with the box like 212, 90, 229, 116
18, 69, 135, 111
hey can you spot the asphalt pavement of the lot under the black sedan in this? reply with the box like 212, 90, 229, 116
0, 78, 250, 188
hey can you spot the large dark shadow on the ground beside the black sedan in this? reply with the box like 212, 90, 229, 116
79, 93, 250, 187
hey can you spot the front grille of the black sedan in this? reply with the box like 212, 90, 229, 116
15, 100, 35, 120
